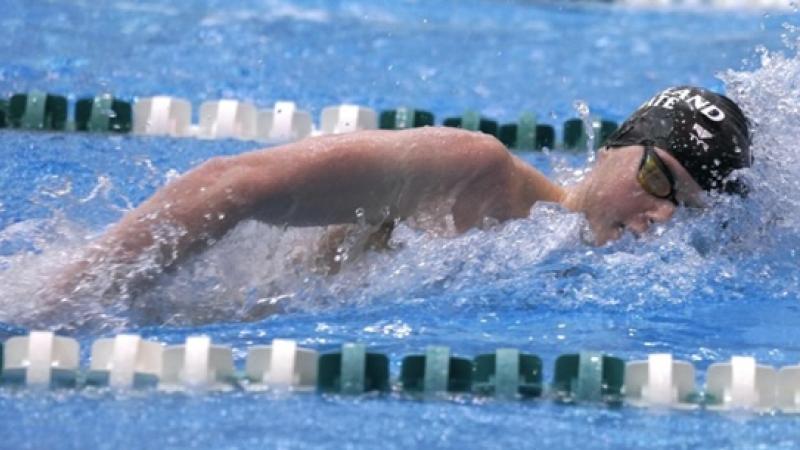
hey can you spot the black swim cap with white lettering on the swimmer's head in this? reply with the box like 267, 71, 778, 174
604, 86, 752, 194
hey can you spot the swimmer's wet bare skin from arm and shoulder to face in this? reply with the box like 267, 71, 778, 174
53, 128, 696, 298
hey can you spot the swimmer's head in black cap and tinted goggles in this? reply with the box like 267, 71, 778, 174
565, 87, 752, 244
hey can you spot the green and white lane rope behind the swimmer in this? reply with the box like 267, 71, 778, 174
0, 90, 617, 151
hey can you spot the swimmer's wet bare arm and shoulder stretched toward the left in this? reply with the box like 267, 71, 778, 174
75, 128, 552, 267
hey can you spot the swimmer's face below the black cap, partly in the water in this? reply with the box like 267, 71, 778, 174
584, 146, 702, 245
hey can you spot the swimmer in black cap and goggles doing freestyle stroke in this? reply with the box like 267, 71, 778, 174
51, 86, 752, 297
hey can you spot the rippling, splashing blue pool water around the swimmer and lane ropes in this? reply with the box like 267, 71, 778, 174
0, 0, 800, 448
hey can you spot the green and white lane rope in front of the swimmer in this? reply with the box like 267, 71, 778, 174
9, 331, 800, 414
